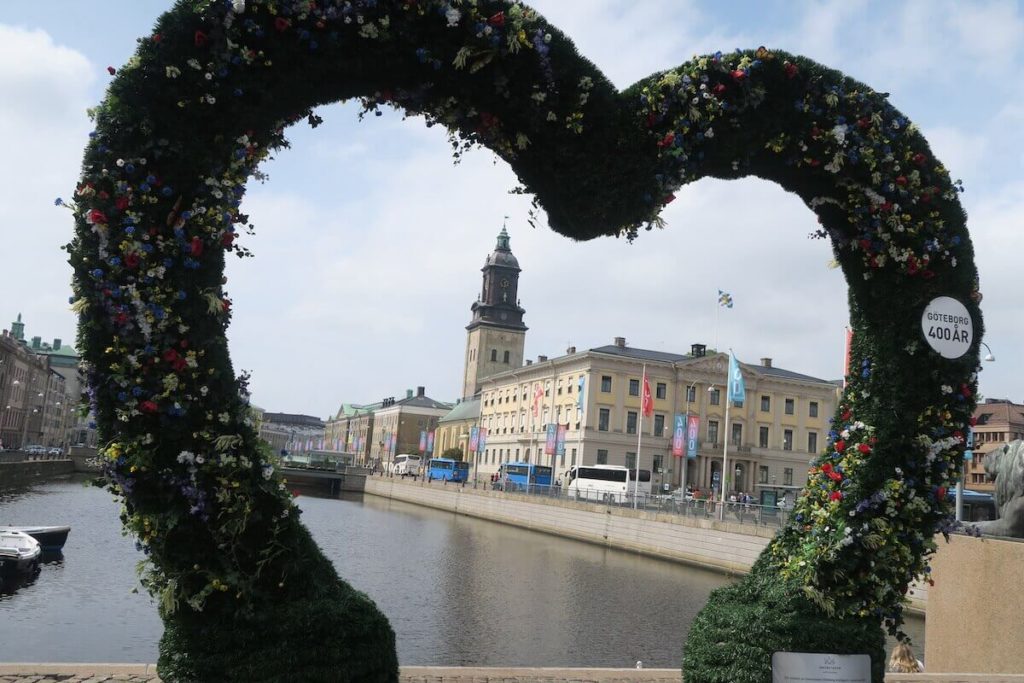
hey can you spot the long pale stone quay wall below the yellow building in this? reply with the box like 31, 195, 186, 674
364, 476, 944, 613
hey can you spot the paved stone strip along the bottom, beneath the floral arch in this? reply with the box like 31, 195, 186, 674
0, 664, 1024, 683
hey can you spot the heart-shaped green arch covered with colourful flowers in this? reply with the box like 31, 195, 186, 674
69, 0, 982, 683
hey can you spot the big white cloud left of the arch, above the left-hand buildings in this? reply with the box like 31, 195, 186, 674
0, 25, 93, 342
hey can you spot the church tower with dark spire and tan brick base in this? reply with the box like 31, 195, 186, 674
462, 227, 526, 398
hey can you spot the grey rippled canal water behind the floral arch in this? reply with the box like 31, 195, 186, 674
0, 479, 925, 667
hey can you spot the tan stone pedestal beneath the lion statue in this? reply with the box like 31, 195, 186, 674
925, 536, 1024, 674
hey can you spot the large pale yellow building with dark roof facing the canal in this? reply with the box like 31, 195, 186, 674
479, 337, 839, 494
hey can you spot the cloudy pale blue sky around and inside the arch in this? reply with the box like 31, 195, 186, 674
0, 0, 1024, 417
